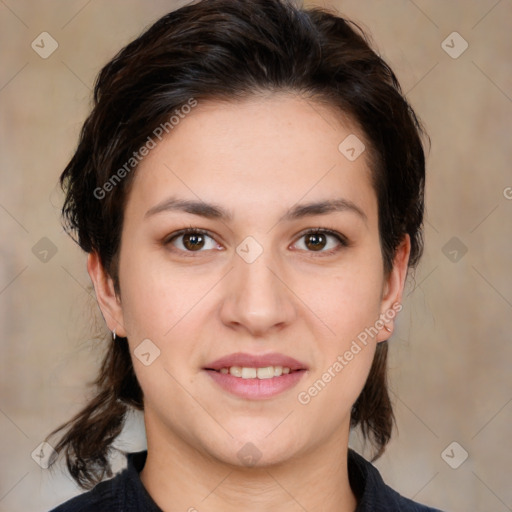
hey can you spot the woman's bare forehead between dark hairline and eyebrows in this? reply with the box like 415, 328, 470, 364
127, 94, 376, 226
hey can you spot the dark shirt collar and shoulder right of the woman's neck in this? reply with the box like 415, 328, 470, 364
348, 450, 442, 512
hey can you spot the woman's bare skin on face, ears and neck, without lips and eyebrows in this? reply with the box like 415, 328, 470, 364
88, 93, 410, 512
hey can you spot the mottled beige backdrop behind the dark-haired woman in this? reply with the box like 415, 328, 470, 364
0, 0, 512, 512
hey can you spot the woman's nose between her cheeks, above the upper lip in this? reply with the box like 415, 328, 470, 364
220, 246, 296, 337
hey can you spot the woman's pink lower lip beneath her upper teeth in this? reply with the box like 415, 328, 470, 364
206, 370, 306, 400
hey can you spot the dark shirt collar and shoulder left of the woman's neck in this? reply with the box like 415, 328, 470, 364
50, 451, 160, 512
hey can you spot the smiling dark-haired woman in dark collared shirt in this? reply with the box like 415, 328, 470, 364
47, 0, 444, 512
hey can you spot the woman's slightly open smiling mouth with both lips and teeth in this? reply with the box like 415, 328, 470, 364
203, 353, 308, 400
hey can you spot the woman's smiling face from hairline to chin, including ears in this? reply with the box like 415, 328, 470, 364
90, 95, 408, 465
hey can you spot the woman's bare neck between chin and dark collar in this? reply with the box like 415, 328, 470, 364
141, 416, 357, 512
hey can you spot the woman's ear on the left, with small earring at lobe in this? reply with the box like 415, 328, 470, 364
87, 252, 126, 338
